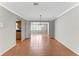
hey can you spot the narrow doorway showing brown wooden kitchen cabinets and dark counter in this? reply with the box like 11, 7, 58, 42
16, 20, 21, 44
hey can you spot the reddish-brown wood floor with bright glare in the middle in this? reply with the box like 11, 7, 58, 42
3, 33, 77, 56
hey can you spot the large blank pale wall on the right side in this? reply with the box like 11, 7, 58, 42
55, 6, 79, 55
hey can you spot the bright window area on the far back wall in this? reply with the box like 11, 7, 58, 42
31, 22, 48, 33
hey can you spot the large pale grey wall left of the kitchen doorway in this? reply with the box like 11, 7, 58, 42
0, 7, 17, 55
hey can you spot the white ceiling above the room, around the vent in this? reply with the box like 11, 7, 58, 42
1, 2, 77, 20
